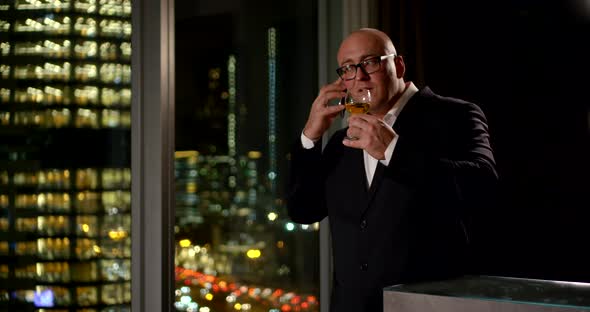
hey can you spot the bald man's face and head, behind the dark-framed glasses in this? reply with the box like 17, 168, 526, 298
337, 32, 403, 115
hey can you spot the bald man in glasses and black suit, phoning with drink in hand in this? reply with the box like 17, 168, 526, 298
287, 29, 497, 312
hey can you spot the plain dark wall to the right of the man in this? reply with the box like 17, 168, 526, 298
381, 0, 590, 281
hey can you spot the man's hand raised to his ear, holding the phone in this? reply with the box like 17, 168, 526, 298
303, 78, 346, 141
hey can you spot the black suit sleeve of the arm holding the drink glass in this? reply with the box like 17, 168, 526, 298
389, 100, 498, 197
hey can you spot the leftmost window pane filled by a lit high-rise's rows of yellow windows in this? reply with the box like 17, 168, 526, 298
0, 0, 131, 312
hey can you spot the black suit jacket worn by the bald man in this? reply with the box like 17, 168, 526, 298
287, 88, 497, 312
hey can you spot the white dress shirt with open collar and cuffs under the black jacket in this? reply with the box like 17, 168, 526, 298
301, 82, 418, 186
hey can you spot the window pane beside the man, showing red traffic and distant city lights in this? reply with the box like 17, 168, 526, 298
175, 0, 319, 312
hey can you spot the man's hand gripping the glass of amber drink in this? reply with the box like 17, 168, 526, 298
342, 114, 397, 160
